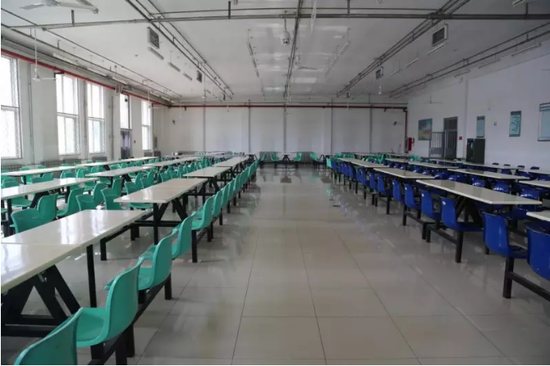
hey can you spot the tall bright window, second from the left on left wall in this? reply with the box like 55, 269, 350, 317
55, 75, 80, 155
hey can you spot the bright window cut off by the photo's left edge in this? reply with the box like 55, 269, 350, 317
0, 56, 22, 159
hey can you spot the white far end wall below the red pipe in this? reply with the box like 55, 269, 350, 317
154, 107, 405, 154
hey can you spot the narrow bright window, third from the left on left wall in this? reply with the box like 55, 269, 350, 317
86, 83, 105, 154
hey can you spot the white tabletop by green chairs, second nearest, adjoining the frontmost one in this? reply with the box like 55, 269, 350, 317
2, 210, 145, 247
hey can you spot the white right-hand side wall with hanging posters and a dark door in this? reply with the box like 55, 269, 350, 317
407, 49, 550, 167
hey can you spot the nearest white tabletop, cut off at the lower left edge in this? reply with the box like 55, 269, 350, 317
0, 243, 83, 293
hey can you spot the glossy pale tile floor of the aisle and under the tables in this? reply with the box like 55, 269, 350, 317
2, 167, 550, 364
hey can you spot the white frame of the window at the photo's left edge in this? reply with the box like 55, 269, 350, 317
0, 55, 23, 160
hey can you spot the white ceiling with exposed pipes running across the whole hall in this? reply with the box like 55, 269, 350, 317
2, 0, 550, 100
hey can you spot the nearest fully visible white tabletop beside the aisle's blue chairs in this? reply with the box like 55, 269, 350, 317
418, 180, 542, 205
